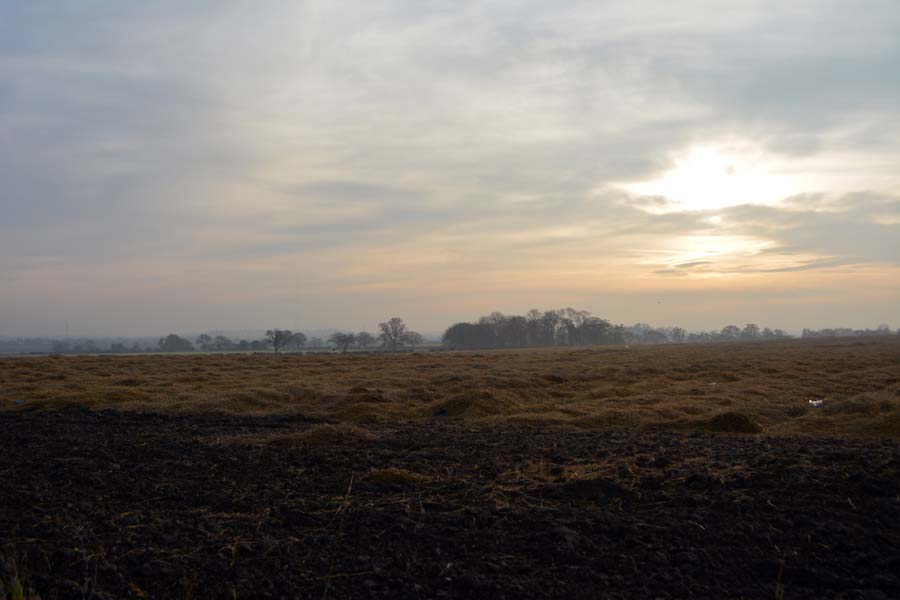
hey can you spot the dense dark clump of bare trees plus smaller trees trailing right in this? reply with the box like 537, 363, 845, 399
443, 308, 790, 350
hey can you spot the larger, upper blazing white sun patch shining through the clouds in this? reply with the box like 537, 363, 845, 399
623, 146, 801, 212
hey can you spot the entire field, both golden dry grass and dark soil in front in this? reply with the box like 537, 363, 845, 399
0, 338, 900, 600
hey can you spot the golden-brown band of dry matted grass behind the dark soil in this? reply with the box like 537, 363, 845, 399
0, 338, 900, 436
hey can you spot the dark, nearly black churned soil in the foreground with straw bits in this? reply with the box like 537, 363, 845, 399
0, 410, 900, 600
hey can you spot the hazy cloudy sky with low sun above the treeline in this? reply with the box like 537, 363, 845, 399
0, 0, 900, 335
